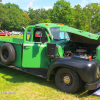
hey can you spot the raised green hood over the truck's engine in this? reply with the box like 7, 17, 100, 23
61, 26, 100, 44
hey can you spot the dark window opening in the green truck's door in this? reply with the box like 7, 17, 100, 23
33, 28, 47, 42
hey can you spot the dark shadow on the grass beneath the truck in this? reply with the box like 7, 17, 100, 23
0, 66, 97, 98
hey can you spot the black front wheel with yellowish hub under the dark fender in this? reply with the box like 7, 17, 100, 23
55, 68, 80, 93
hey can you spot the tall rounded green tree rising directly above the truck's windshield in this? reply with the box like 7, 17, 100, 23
50, 0, 73, 26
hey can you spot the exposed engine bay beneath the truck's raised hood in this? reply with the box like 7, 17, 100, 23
64, 41, 98, 59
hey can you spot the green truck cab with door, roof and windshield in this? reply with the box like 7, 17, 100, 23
22, 23, 69, 69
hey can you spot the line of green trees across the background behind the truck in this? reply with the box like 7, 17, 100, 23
0, 0, 100, 33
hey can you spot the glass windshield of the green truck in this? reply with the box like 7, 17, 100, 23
50, 27, 69, 40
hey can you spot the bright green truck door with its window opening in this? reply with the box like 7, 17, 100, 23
22, 28, 50, 68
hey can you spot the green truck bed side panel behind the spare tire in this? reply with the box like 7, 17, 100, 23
0, 38, 23, 68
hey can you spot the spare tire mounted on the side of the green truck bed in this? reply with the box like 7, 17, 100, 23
0, 43, 15, 65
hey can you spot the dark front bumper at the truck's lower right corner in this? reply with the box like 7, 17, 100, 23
86, 79, 100, 90
